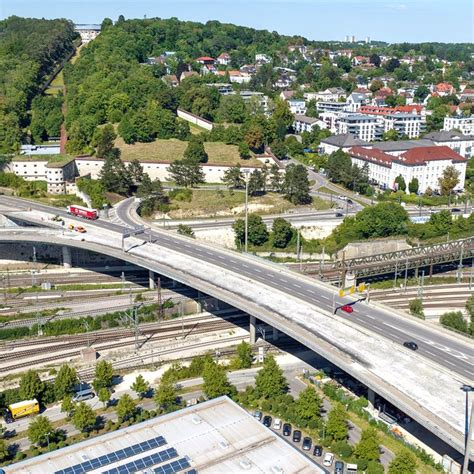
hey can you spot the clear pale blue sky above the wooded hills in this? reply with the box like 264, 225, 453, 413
0, 0, 474, 42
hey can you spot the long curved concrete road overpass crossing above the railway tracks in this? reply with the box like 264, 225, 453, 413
0, 193, 474, 460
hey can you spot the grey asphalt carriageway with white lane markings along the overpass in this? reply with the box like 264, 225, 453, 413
0, 196, 474, 380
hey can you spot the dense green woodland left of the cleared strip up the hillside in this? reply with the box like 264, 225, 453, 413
0, 16, 78, 153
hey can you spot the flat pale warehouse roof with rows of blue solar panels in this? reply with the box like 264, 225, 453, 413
4, 397, 324, 474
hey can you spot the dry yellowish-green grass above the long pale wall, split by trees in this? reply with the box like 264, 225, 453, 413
115, 137, 262, 167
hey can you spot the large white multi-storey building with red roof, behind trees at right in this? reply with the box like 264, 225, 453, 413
349, 146, 467, 193
